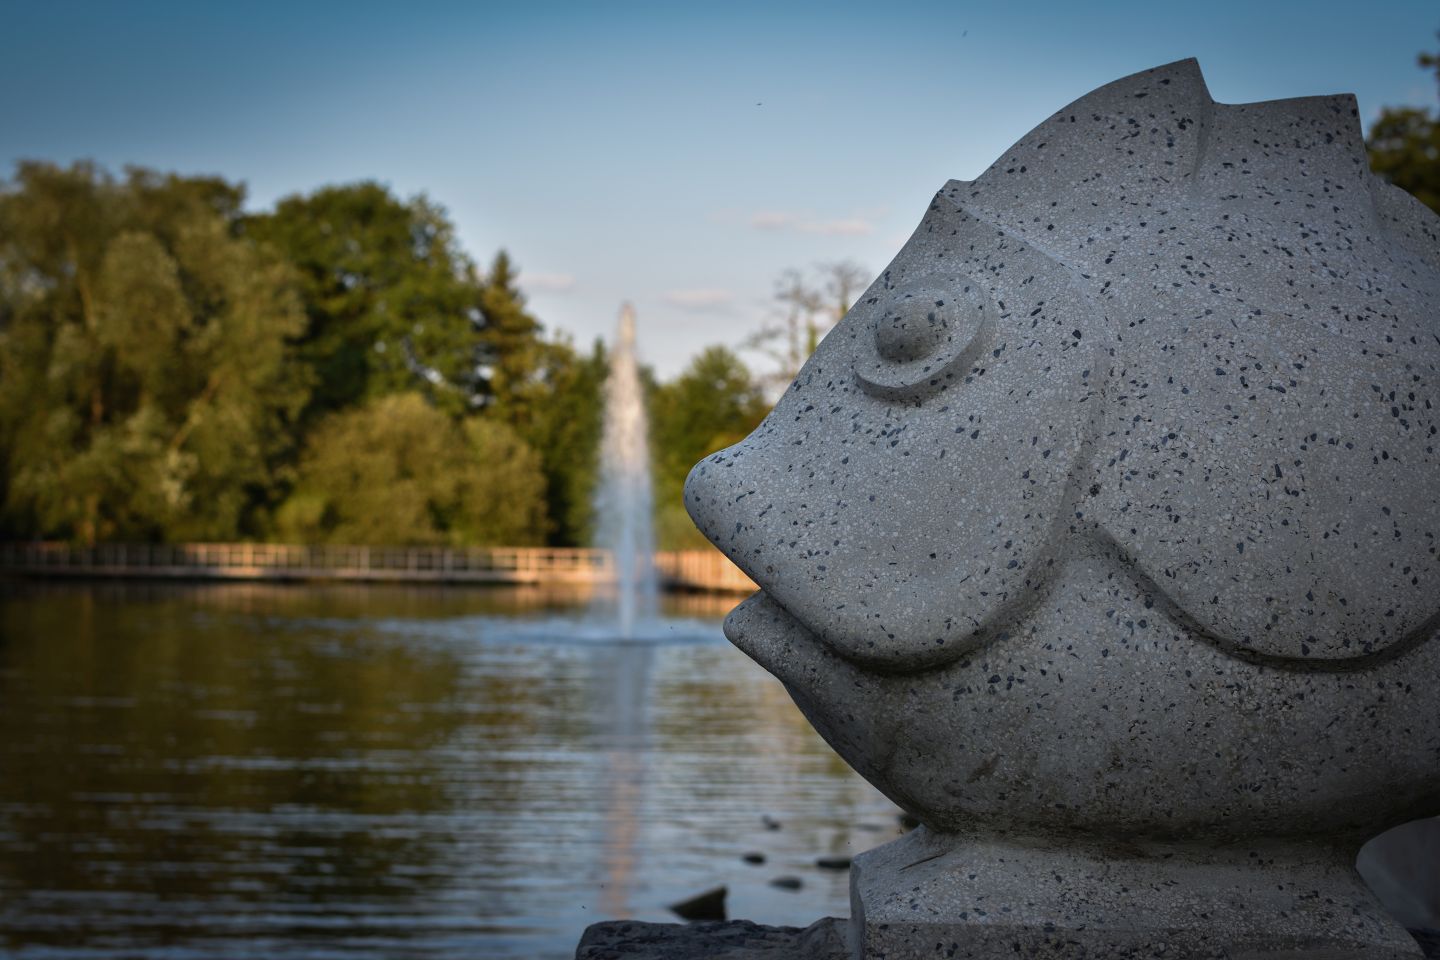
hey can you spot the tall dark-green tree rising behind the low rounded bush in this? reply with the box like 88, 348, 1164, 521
245, 183, 482, 419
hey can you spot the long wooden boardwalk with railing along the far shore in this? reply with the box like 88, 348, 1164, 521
0, 543, 756, 593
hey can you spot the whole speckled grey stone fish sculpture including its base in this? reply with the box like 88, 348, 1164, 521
685, 60, 1440, 960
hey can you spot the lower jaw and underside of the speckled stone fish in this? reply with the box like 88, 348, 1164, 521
724, 556, 1440, 839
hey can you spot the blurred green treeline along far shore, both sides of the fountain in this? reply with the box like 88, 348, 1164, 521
0, 163, 766, 547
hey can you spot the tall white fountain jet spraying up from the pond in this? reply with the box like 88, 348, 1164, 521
595, 304, 658, 638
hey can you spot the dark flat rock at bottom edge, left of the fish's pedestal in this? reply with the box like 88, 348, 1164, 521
575, 917, 850, 960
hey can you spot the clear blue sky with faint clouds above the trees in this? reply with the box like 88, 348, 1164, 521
8, 0, 1440, 376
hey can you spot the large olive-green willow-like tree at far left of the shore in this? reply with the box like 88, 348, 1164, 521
0, 163, 308, 543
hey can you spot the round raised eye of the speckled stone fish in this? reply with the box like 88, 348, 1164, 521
854, 282, 996, 403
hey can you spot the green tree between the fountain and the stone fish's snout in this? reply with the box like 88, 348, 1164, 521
651, 347, 769, 550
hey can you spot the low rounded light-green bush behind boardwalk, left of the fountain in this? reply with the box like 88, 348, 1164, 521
276, 393, 546, 545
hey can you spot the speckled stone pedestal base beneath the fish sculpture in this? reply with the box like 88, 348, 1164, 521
850, 828, 1423, 960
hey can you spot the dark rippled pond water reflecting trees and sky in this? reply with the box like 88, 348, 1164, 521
0, 583, 897, 960
